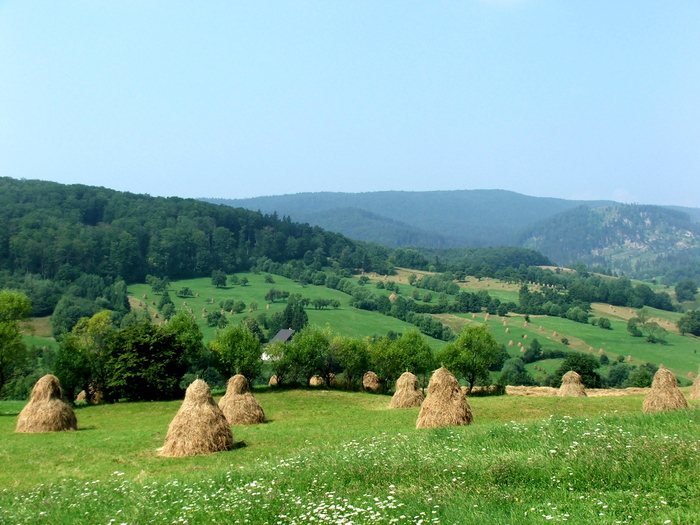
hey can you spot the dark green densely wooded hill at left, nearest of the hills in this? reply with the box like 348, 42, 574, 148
0, 177, 386, 282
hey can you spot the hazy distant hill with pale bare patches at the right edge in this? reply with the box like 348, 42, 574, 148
518, 204, 700, 278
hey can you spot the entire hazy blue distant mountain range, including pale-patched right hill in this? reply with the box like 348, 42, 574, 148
202, 190, 700, 276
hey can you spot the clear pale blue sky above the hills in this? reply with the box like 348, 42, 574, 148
0, 0, 700, 207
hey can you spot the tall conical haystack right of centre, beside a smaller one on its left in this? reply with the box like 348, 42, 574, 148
416, 367, 472, 428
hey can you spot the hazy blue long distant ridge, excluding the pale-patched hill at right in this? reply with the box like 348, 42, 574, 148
203, 190, 613, 248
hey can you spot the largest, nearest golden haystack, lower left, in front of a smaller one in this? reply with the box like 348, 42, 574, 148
160, 379, 233, 458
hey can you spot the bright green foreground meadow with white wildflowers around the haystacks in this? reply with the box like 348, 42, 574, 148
0, 390, 700, 523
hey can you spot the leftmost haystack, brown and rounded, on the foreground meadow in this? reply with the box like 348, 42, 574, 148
15, 374, 78, 433
